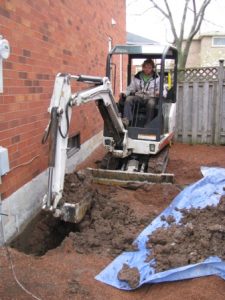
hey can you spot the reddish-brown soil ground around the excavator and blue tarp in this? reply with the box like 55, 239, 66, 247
0, 144, 225, 300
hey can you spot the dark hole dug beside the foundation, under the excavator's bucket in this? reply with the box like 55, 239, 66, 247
10, 211, 79, 256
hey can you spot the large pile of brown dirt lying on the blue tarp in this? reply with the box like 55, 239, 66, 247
147, 196, 225, 272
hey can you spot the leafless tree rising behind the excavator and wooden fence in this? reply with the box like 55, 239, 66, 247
149, 0, 211, 70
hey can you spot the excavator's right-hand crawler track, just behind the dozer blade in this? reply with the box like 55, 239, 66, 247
148, 146, 169, 174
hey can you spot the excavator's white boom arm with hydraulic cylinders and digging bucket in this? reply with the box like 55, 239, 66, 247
43, 74, 126, 222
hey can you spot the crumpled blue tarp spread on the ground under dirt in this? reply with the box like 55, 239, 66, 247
95, 167, 225, 290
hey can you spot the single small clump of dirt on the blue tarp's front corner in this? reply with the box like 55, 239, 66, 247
117, 264, 140, 289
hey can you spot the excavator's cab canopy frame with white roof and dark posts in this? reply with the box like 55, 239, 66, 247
106, 43, 178, 141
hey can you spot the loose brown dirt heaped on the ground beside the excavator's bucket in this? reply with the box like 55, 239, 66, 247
64, 174, 154, 256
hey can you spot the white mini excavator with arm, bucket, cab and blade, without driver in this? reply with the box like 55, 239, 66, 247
43, 44, 177, 223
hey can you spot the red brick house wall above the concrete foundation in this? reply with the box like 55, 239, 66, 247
0, 0, 126, 198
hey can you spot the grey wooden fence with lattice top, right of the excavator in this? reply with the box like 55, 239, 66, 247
175, 60, 225, 144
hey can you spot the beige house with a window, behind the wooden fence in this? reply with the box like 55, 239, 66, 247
184, 32, 225, 68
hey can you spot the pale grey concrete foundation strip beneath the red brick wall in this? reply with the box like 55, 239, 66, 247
0, 132, 102, 245
